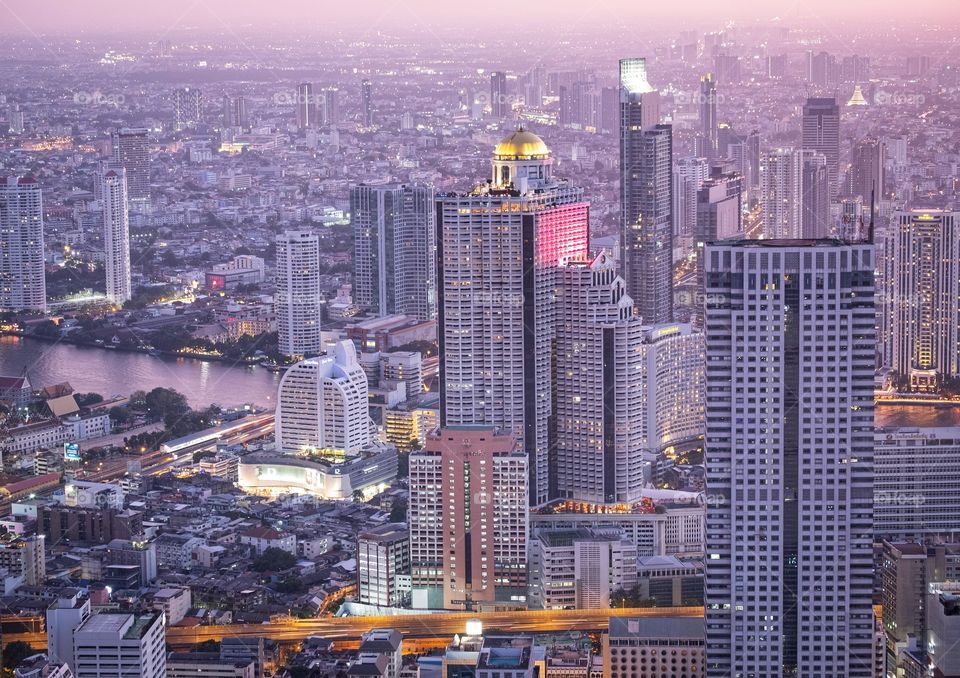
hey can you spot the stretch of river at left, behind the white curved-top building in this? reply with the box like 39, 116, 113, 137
0, 336, 280, 409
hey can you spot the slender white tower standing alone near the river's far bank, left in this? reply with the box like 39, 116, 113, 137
100, 167, 133, 305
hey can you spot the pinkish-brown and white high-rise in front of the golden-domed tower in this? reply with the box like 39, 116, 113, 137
410, 426, 529, 610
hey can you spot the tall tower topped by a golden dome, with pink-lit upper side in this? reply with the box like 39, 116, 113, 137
436, 129, 589, 504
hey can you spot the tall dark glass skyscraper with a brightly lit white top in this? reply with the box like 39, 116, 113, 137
620, 59, 673, 323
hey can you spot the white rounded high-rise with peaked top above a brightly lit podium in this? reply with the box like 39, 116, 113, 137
276, 341, 370, 453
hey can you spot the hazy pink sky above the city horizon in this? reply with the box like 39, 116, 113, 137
0, 0, 960, 39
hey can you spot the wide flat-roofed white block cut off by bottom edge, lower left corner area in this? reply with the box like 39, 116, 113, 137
71, 612, 167, 678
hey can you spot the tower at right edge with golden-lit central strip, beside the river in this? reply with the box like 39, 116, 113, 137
880, 209, 960, 390
